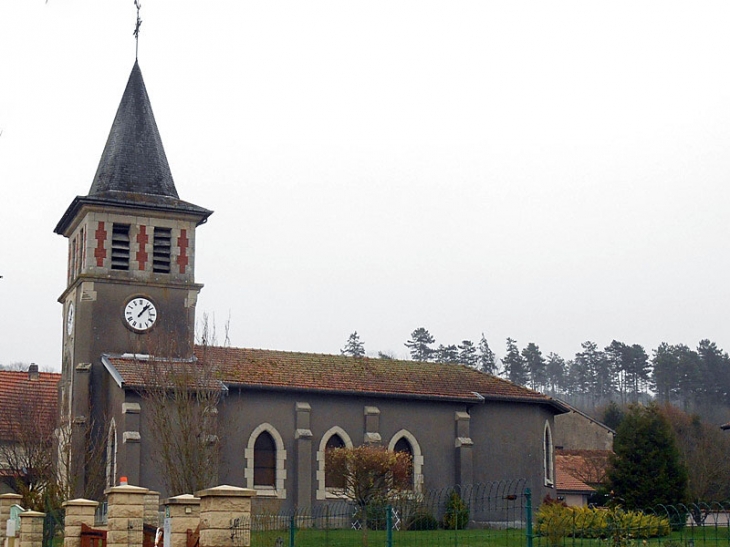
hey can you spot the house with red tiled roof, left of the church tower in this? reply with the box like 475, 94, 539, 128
0, 364, 61, 494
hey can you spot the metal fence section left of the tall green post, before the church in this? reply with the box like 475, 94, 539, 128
231, 480, 529, 547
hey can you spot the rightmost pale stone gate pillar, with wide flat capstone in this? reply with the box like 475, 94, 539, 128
195, 485, 256, 547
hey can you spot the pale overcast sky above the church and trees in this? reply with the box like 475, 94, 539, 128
0, 0, 730, 368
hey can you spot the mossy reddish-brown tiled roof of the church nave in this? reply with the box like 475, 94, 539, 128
107, 346, 567, 411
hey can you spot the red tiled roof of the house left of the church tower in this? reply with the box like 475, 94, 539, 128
0, 370, 61, 440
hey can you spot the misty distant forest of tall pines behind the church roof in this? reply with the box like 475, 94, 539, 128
342, 327, 730, 424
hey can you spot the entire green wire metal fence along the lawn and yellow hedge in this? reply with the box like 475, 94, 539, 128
231, 490, 730, 547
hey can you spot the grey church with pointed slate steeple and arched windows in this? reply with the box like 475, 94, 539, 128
55, 61, 568, 508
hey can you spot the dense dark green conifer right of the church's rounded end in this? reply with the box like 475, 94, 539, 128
608, 404, 687, 510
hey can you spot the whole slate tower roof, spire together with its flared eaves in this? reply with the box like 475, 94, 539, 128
55, 61, 212, 233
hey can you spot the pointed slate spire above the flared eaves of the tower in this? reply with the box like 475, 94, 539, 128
89, 61, 178, 198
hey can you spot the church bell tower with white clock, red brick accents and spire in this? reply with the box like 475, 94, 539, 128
55, 61, 212, 494
